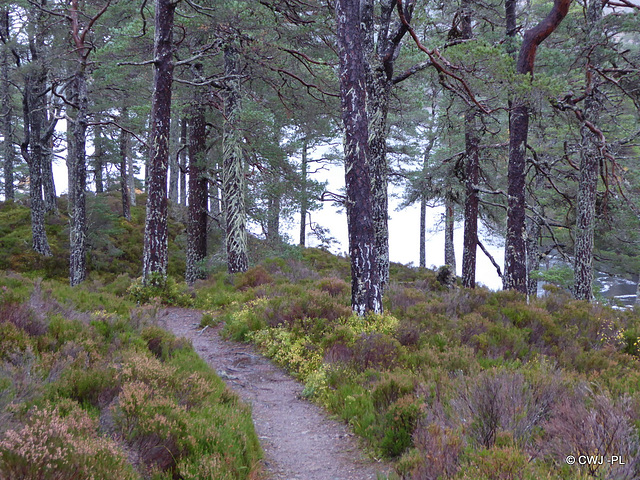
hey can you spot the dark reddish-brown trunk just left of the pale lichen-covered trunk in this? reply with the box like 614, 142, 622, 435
185, 101, 209, 285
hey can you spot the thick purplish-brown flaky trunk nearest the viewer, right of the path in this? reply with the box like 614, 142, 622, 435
336, 0, 382, 315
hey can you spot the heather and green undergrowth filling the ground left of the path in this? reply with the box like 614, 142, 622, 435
0, 274, 261, 480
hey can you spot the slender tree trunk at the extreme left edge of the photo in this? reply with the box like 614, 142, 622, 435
0, 8, 15, 201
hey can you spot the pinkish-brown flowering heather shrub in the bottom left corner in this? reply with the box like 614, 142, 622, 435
0, 401, 139, 480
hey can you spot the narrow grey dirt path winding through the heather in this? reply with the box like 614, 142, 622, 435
162, 308, 387, 480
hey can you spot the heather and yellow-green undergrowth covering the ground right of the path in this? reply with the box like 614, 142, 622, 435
196, 253, 640, 480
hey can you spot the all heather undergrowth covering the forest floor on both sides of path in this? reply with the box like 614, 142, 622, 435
0, 195, 640, 480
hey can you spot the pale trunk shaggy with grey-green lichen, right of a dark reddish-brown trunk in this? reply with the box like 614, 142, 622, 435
222, 46, 249, 273
